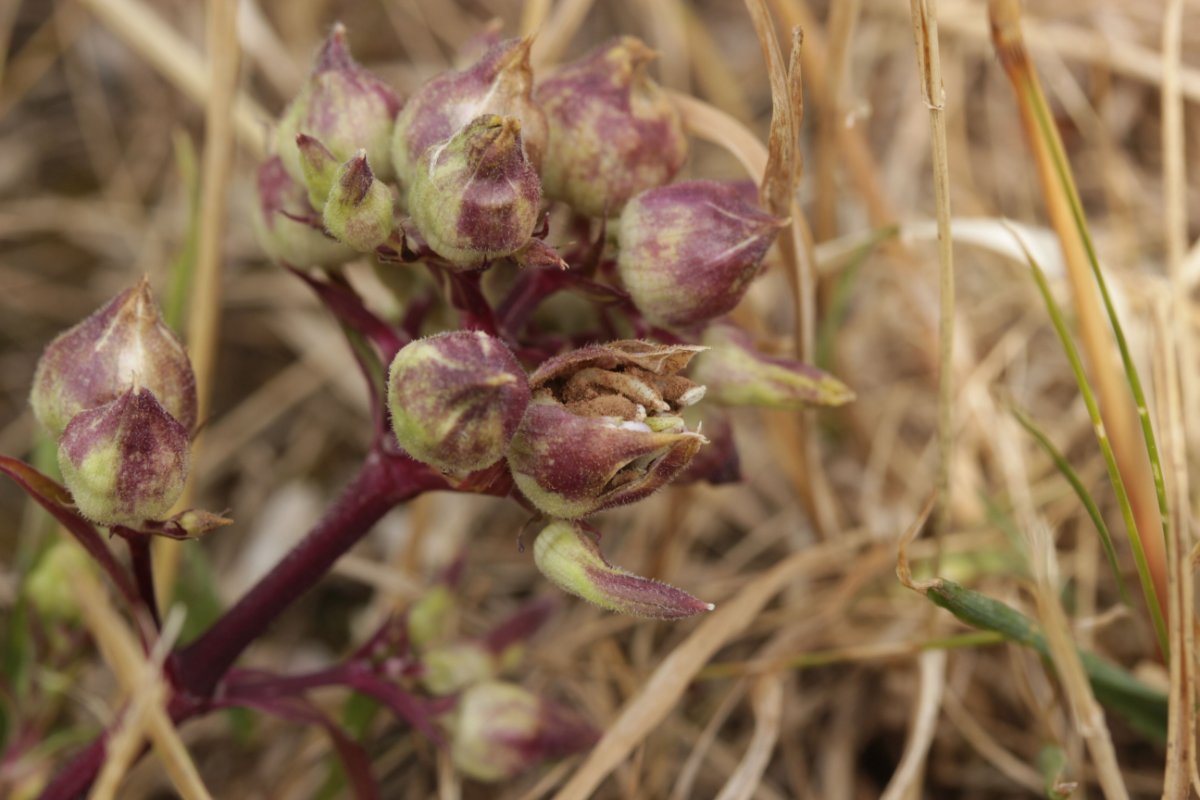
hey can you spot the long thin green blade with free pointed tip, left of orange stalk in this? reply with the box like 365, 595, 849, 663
1014, 233, 1170, 658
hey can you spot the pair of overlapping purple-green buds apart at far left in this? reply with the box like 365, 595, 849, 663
30, 279, 197, 528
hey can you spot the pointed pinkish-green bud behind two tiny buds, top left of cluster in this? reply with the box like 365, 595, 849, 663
275, 25, 403, 188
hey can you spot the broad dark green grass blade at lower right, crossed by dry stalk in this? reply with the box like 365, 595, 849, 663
925, 579, 1168, 742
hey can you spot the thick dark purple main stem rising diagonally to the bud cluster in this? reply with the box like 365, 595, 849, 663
175, 451, 444, 697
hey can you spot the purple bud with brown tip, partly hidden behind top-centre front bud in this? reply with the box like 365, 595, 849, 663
391, 38, 548, 185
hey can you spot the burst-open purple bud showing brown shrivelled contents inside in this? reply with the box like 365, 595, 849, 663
506, 342, 706, 519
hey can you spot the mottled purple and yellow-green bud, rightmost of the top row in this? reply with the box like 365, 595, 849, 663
535, 36, 688, 217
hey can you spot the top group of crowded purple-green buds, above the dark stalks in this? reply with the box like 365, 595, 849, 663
258, 25, 688, 271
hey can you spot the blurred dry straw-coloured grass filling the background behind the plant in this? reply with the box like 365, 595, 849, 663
0, 0, 1200, 799
